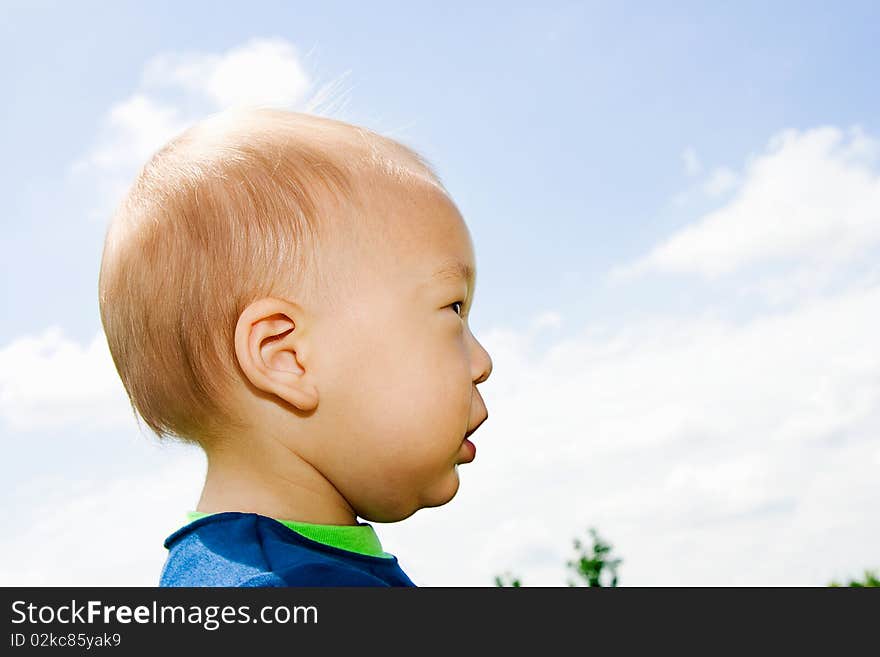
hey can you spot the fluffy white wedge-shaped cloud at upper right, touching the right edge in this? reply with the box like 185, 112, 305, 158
611, 127, 880, 280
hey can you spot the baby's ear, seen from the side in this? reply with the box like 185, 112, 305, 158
235, 298, 318, 411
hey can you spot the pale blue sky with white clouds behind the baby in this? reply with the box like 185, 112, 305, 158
0, 2, 880, 585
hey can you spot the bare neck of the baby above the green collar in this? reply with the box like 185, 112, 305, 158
195, 437, 358, 525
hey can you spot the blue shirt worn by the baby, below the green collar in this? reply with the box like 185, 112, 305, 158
159, 511, 415, 586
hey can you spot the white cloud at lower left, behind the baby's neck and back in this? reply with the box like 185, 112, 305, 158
0, 448, 205, 586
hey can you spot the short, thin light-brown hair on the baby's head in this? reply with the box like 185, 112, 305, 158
98, 108, 446, 446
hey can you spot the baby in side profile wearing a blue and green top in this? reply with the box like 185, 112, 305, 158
99, 108, 492, 586
